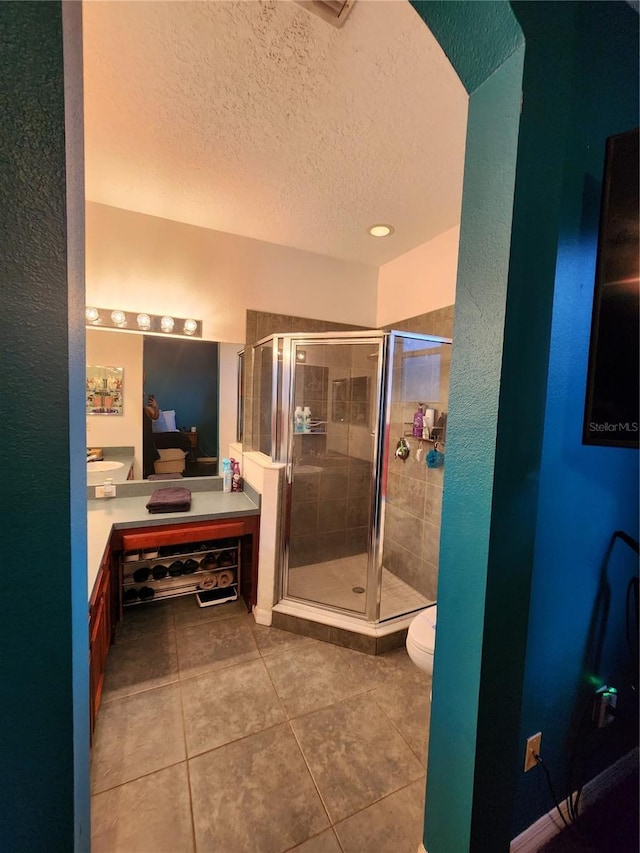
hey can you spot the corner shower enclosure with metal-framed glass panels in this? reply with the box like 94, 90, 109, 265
253, 331, 451, 625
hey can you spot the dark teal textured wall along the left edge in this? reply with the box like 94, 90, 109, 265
0, 2, 89, 853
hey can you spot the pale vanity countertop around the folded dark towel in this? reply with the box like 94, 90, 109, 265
87, 480, 260, 597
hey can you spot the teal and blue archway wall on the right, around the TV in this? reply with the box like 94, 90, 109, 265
414, 2, 638, 853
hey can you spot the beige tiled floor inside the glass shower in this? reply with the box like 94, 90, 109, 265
288, 554, 433, 619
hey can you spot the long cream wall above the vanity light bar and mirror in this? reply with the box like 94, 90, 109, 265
86, 202, 378, 343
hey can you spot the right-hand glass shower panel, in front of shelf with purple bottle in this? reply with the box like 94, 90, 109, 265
377, 332, 451, 620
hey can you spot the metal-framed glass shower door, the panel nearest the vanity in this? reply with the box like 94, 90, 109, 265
283, 336, 383, 616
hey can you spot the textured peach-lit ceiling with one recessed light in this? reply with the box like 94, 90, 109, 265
83, 0, 467, 266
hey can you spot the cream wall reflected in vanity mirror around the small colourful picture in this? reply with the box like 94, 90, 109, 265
87, 329, 143, 479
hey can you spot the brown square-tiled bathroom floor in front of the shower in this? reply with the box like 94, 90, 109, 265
91, 598, 430, 853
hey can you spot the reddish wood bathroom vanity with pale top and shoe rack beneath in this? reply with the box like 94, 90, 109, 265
87, 478, 260, 731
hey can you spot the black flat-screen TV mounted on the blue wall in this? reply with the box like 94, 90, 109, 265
582, 128, 640, 448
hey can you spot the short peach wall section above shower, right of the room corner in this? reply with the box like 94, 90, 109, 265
376, 225, 460, 326
